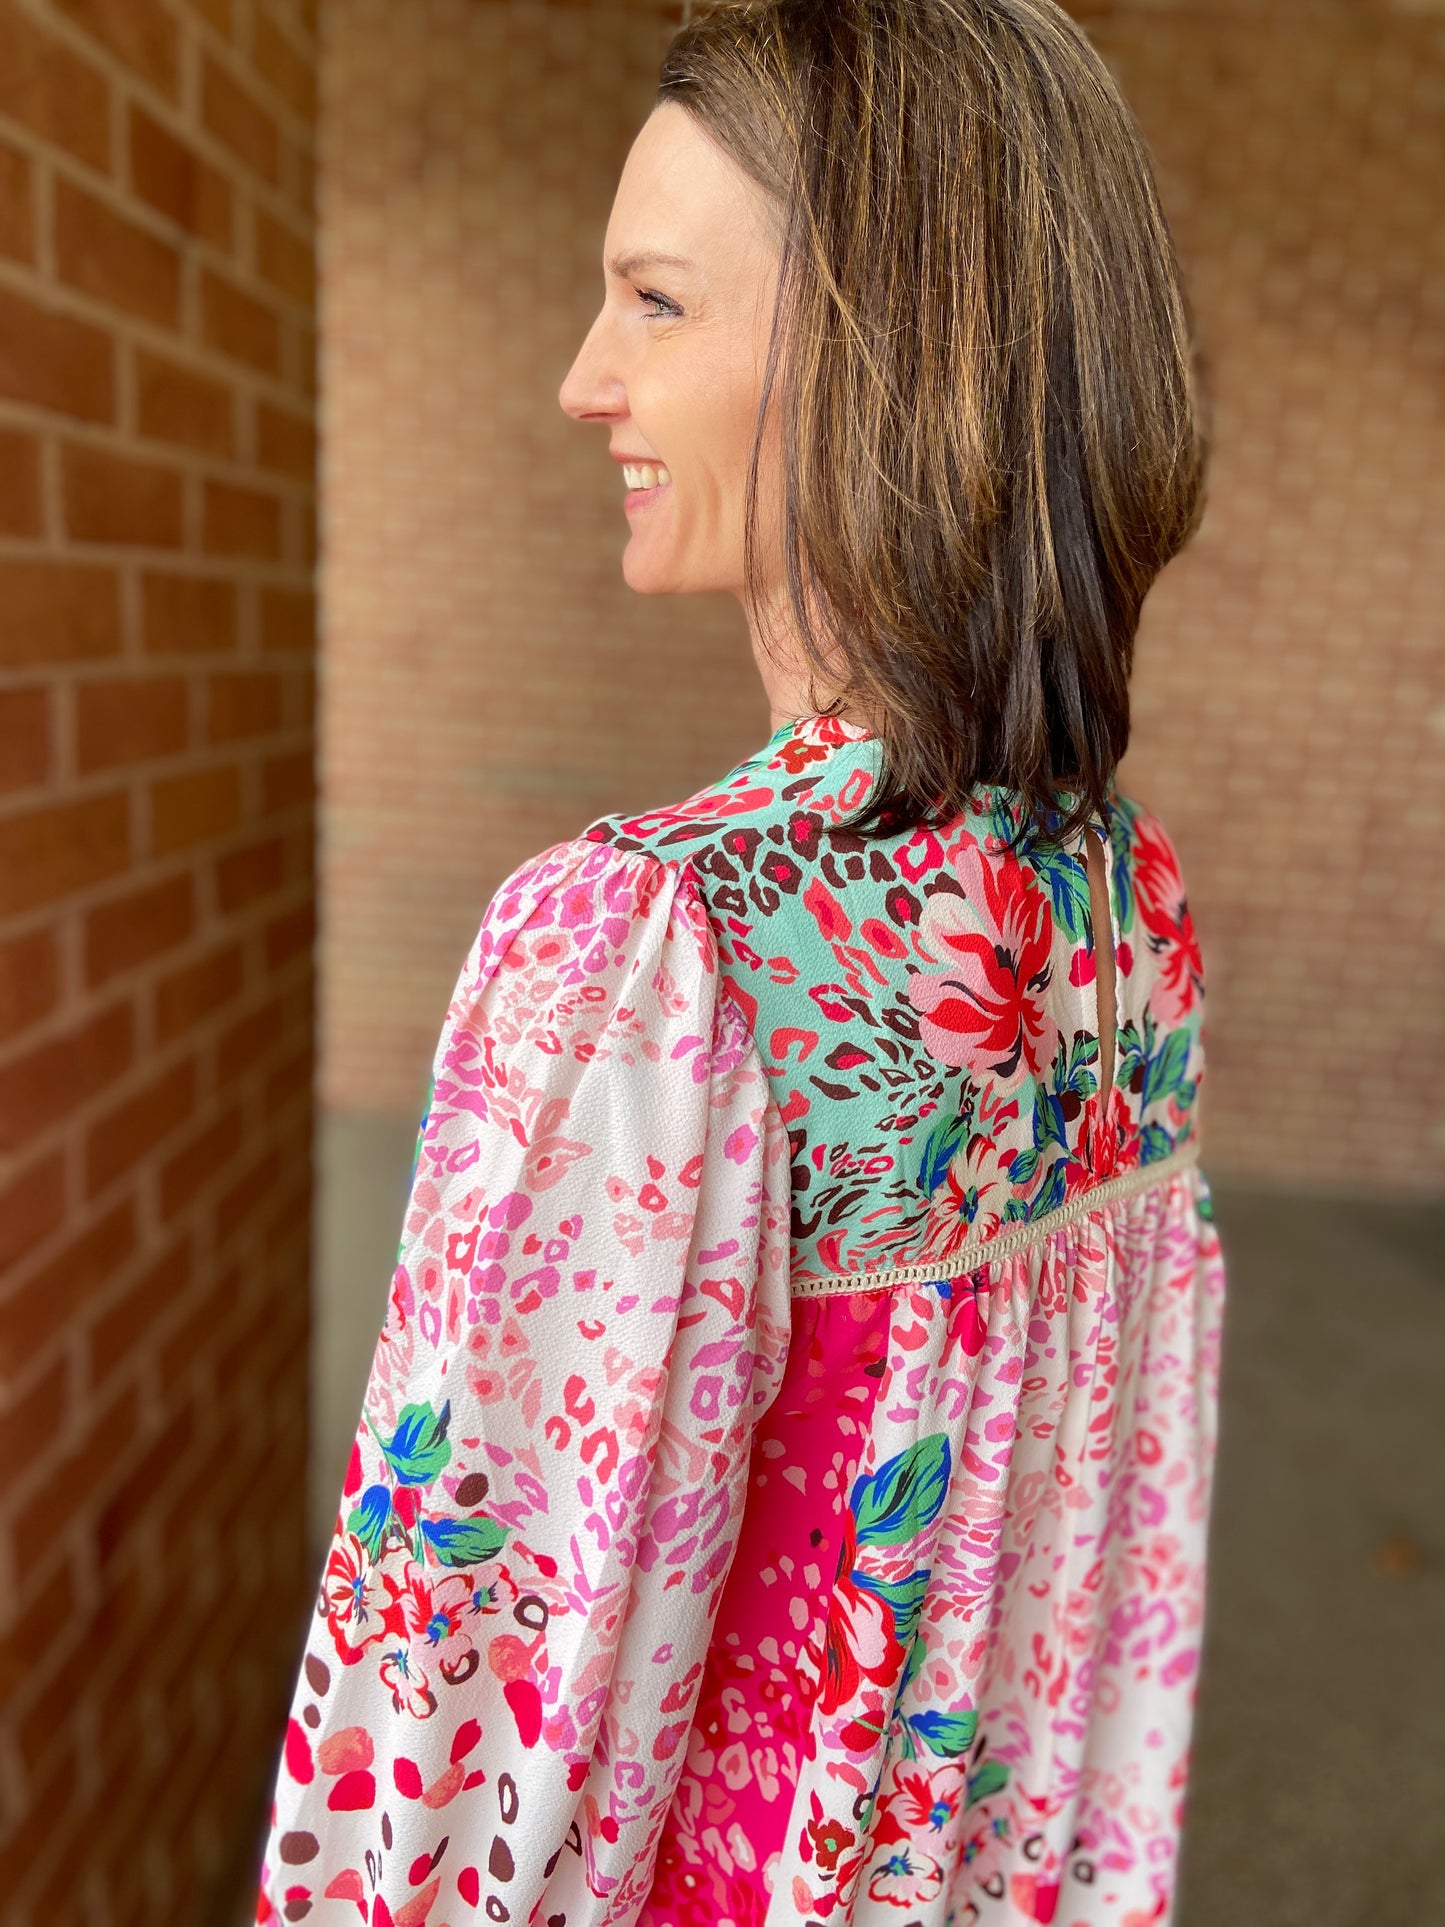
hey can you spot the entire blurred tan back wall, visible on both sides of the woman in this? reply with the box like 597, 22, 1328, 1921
322, 0, 1445, 1191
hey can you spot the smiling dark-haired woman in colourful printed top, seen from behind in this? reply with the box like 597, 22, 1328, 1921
258, 0, 1223, 1927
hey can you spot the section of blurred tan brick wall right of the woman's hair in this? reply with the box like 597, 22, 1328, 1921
1081, 0, 1445, 1193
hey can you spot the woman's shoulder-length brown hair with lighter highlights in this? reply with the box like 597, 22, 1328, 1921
657, 0, 1206, 836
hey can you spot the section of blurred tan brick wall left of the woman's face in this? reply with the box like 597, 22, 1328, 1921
320, 0, 767, 1116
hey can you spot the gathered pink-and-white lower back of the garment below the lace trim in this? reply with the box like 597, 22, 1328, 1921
640, 1174, 1223, 1927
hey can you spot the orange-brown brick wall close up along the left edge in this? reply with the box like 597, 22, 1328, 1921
0, 0, 316, 1927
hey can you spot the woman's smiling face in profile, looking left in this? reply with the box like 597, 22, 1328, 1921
557, 102, 778, 601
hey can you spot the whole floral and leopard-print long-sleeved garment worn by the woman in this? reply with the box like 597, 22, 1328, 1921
256, 717, 1223, 1927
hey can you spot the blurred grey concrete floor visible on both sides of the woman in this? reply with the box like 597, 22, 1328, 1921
208, 1118, 1445, 1927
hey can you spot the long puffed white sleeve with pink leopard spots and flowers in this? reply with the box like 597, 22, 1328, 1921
256, 838, 805, 1927
